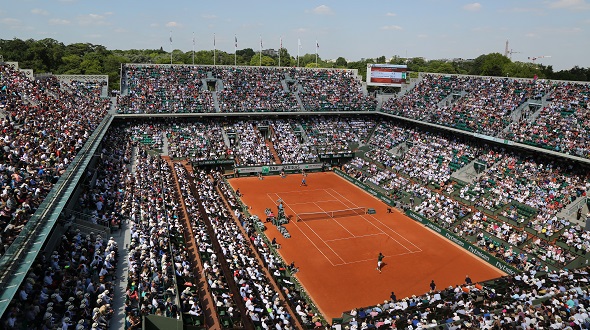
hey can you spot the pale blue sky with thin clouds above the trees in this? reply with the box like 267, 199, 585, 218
0, 0, 590, 71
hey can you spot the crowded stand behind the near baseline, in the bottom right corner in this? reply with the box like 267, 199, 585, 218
338, 268, 590, 329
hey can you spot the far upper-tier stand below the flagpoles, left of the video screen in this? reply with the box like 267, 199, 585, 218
118, 64, 377, 113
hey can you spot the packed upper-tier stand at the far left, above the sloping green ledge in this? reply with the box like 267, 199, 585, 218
0, 65, 108, 254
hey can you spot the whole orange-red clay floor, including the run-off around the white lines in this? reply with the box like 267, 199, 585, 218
230, 172, 504, 320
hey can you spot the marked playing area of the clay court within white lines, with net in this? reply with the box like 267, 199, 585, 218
267, 187, 421, 266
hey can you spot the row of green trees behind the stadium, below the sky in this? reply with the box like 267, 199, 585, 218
0, 38, 590, 89
